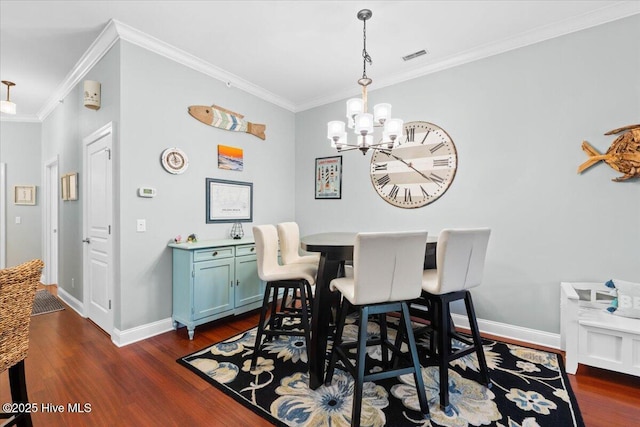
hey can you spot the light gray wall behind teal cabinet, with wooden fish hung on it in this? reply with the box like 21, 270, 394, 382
116, 42, 295, 330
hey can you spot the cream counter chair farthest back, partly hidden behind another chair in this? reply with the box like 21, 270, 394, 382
276, 222, 320, 308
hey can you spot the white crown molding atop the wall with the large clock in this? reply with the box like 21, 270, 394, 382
294, 0, 640, 113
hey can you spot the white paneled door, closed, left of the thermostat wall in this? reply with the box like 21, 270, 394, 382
82, 123, 113, 335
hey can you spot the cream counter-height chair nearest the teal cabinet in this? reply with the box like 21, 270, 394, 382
251, 225, 317, 368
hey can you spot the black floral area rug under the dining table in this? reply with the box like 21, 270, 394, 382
178, 318, 584, 427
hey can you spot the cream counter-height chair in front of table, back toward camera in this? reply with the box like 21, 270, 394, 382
325, 232, 429, 426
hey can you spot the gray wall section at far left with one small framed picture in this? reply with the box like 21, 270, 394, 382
0, 121, 42, 267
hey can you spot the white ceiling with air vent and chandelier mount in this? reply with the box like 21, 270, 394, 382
0, 0, 640, 120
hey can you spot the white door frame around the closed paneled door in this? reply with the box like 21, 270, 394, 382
82, 122, 117, 336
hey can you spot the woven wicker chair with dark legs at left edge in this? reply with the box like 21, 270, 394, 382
0, 259, 44, 427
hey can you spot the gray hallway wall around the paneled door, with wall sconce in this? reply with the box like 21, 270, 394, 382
42, 43, 120, 301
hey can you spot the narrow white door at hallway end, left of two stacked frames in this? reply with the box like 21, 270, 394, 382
44, 157, 59, 285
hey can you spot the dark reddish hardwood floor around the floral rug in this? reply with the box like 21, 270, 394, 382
0, 290, 640, 427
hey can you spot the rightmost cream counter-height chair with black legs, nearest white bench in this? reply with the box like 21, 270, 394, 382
410, 228, 491, 413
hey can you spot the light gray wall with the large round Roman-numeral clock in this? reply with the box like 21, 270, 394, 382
295, 16, 640, 332
